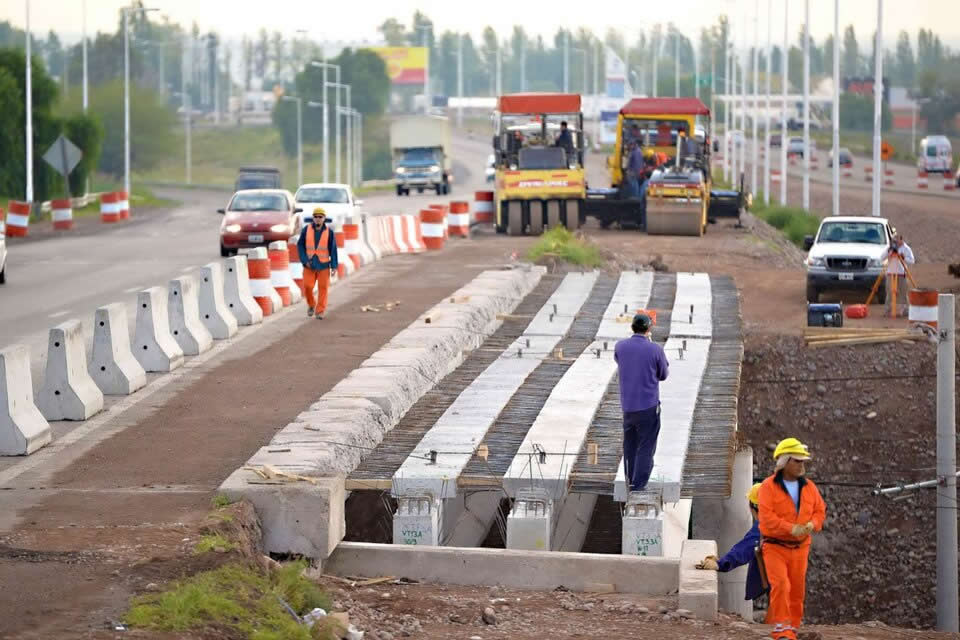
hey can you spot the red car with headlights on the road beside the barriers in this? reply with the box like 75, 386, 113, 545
217, 189, 301, 257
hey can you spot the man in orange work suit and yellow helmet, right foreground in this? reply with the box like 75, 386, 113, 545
758, 438, 827, 640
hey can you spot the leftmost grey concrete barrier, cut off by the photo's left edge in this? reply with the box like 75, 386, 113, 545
0, 344, 52, 456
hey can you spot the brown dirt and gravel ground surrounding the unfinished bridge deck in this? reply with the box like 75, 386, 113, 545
0, 171, 960, 640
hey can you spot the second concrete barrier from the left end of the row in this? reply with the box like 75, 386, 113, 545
37, 320, 103, 420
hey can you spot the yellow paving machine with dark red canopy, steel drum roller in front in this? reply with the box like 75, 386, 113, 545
584, 98, 747, 236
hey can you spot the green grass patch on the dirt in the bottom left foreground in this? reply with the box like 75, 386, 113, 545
126, 562, 330, 640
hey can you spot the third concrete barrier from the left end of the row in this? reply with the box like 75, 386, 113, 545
88, 302, 147, 396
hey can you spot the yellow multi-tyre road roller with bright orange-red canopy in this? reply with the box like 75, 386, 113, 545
493, 93, 586, 235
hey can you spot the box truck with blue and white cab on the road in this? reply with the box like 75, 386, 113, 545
390, 116, 453, 196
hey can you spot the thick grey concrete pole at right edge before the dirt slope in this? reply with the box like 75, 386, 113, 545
932, 294, 960, 633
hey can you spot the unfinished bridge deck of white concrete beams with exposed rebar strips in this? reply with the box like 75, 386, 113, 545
222, 268, 751, 619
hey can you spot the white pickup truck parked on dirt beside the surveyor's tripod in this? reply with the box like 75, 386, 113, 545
803, 216, 895, 304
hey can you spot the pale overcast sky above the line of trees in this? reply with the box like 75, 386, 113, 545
7, 0, 960, 49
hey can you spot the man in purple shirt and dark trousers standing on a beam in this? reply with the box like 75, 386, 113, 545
613, 313, 670, 491
